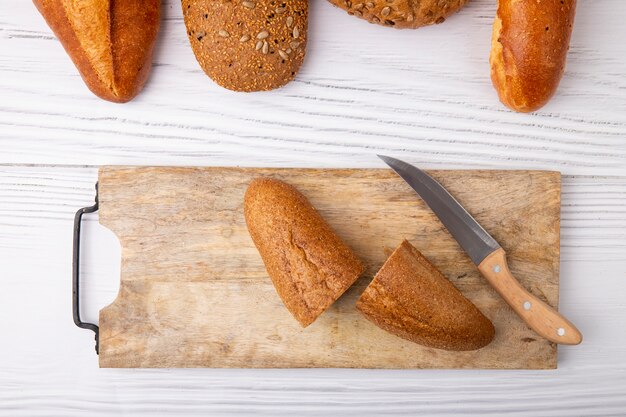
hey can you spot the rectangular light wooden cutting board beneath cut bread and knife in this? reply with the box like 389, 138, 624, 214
99, 167, 560, 369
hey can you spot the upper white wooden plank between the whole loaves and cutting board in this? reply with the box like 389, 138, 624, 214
0, 0, 626, 175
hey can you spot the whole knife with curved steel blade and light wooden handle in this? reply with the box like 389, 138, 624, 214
378, 155, 582, 345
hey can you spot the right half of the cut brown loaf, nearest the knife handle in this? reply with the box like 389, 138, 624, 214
357, 240, 495, 350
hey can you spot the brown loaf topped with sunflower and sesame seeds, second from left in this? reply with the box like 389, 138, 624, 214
182, 0, 308, 91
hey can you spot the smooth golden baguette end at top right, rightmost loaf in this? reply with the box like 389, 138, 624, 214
489, 0, 576, 112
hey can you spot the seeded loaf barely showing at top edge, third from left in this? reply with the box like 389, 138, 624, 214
329, 0, 467, 29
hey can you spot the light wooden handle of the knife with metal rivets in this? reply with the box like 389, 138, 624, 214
478, 248, 583, 345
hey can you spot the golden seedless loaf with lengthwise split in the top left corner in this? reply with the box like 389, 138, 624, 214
33, 0, 160, 103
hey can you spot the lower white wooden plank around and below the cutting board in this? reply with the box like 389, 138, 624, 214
0, 167, 626, 417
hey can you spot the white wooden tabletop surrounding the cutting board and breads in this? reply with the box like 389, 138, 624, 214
0, 0, 626, 417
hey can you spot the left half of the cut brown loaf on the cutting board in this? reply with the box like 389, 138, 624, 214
244, 178, 364, 327
